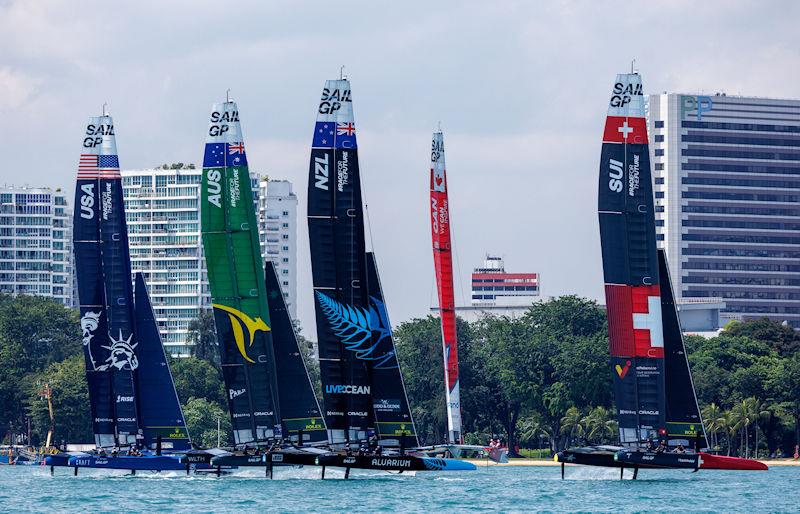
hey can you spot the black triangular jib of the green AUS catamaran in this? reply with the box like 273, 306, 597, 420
264, 261, 328, 442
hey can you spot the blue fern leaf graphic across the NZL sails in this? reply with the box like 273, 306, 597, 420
315, 291, 397, 369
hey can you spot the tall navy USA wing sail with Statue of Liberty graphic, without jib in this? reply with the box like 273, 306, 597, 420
73, 112, 139, 447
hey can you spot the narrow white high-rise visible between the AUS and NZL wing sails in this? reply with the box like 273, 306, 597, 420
258, 178, 297, 319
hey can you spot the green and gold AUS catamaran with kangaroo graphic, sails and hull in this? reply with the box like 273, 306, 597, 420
192, 96, 327, 476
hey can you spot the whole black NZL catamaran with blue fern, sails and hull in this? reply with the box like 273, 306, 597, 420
308, 78, 474, 476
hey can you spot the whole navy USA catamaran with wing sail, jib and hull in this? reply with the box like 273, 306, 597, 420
46, 113, 196, 474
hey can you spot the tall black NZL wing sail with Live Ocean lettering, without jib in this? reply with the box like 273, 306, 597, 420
308, 78, 373, 444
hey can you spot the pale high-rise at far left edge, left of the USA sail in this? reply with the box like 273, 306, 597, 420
0, 186, 74, 307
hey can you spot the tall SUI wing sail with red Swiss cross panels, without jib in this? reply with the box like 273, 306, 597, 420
598, 73, 666, 446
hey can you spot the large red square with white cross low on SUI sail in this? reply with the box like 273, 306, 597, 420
606, 284, 664, 358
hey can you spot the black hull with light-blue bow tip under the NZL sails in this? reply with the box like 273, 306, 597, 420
319, 453, 477, 471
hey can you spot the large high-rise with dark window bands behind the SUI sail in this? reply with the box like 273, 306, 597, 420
648, 93, 800, 327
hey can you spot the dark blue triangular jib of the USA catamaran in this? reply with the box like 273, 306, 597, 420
134, 273, 191, 450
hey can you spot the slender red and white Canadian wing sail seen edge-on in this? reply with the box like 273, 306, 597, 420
430, 130, 464, 444
